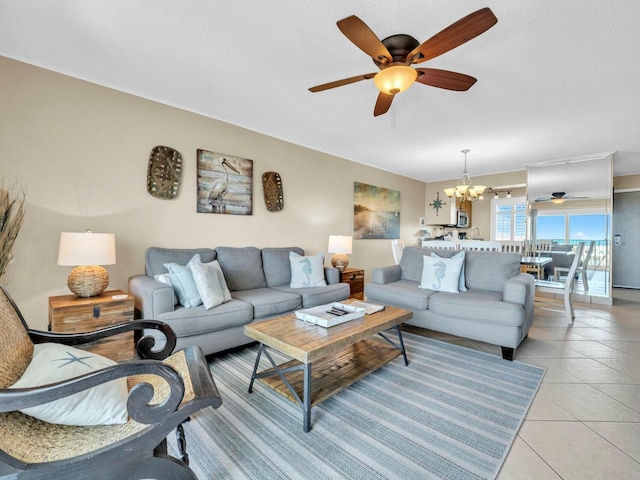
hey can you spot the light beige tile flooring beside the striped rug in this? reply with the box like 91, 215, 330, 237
407, 289, 640, 480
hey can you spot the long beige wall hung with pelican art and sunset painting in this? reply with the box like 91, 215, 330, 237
0, 57, 425, 328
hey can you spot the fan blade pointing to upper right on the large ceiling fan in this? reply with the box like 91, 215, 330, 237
407, 7, 498, 63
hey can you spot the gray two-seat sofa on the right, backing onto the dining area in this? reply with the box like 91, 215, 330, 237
365, 247, 535, 360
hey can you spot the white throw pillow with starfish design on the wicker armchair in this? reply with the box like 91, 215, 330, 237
11, 343, 128, 426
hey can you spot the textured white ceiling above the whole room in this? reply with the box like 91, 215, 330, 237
0, 0, 640, 181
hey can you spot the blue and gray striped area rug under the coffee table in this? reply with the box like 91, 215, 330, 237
169, 333, 544, 480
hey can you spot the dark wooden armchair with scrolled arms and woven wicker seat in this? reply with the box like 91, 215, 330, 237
0, 287, 222, 479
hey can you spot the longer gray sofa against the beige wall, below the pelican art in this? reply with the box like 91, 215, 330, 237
129, 247, 350, 355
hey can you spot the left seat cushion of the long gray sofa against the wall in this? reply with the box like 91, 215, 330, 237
157, 300, 253, 337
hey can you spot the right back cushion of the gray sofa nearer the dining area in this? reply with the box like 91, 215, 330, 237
465, 251, 522, 292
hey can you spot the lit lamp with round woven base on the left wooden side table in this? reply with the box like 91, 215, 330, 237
58, 230, 116, 297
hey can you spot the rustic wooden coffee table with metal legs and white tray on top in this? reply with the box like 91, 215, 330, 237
244, 301, 413, 432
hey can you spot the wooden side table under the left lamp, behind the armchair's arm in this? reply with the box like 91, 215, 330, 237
49, 290, 134, 362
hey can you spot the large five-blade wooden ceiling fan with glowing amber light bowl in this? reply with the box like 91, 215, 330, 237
309, 7, 498, 117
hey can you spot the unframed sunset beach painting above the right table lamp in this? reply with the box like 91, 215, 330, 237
353, 182, 400, 239
